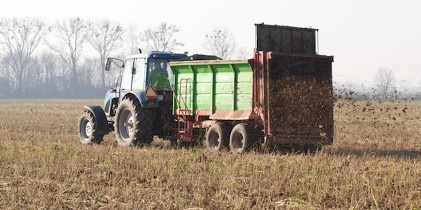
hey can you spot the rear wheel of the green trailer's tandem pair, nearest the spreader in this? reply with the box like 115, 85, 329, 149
229, 123, 255, 153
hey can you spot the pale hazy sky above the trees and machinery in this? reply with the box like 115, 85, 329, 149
0, 0, 421, 85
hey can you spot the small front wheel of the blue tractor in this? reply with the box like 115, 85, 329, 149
78, 110, 104, 144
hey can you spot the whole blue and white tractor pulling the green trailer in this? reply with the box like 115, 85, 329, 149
79, 51, 188, 146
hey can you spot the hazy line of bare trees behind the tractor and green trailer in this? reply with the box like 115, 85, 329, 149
0, 17, 243, 98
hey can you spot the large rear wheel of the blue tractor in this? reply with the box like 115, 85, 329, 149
114, 97, 153, 146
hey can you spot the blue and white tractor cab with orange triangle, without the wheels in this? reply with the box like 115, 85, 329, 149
104, 51, 187, 117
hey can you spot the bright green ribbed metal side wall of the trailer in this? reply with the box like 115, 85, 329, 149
170, 60, 253, 114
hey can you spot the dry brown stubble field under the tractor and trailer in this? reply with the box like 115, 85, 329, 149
0, 100, 421, 209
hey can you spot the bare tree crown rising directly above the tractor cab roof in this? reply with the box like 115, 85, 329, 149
140, 23, 183, 51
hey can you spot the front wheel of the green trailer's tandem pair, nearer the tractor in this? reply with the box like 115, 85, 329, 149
205, 122, 229, 151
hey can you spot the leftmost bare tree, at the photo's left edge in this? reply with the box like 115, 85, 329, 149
0, 18, 46, 96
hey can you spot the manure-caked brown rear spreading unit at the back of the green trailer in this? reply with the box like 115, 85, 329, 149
254, 52, 333, 144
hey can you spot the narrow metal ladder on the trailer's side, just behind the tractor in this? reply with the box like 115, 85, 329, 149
177, 78, 193, 142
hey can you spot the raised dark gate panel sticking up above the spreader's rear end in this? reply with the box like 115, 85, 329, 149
256, 24, 318, 55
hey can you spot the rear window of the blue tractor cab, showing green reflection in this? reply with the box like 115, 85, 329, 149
148, 58, 174, 90
